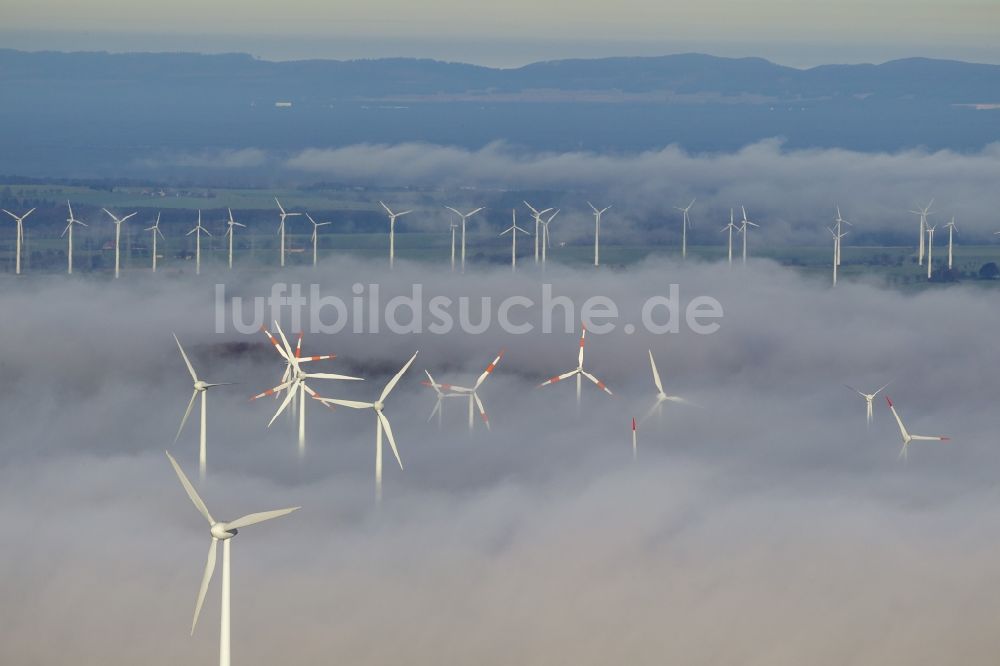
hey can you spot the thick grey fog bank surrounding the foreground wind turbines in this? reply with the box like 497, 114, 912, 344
0, 253, 1000, 666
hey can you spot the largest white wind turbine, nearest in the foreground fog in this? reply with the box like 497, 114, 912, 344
167, 451, 301, 666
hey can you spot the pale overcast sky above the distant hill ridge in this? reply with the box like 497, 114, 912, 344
3, 0, 1000, 66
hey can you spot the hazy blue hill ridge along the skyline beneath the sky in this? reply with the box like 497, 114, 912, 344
0, 49, 1000, 104
